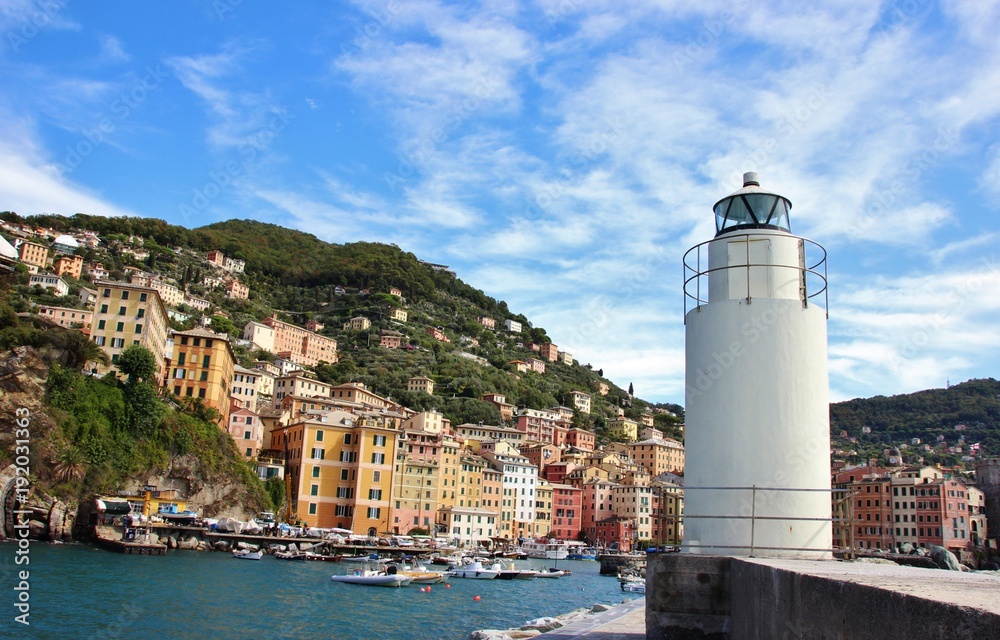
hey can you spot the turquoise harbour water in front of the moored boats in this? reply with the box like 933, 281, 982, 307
0, 543, 635, 640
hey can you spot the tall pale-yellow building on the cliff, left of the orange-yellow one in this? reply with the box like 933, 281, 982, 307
90, 280, 169, 374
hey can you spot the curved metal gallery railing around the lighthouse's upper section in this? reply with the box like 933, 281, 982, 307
683, 231, 830, 318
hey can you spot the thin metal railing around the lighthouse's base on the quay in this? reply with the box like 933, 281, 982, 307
657, 485, 853, 557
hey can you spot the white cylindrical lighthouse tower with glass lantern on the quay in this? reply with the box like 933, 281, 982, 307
682, 173, 832, 558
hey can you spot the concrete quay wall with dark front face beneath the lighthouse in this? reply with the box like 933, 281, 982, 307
646, 554, 1000, 640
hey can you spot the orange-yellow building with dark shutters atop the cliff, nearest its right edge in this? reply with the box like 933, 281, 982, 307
167, 329, 236, 430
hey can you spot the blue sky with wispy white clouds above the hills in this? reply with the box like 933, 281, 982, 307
0, 0, 1000, 402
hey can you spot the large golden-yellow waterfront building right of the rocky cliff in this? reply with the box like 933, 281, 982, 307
270, 411, 399, 535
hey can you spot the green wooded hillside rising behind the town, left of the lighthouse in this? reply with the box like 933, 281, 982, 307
0, 212, 683, 436
